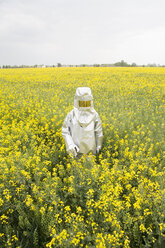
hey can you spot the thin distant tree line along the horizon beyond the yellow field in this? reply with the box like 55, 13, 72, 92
0, 60, 165, 69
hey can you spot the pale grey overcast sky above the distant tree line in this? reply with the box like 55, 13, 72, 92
0, 0, 165, 65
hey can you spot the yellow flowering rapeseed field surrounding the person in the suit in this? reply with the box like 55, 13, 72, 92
0, 68, 165, 248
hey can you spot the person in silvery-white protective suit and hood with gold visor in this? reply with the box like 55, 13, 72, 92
62, 87, 103, 158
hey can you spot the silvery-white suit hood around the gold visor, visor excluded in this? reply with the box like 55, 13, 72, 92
74, 87, 95, 126
